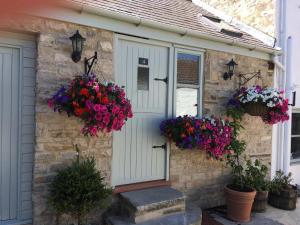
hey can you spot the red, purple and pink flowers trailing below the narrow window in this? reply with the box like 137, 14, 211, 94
160, 115, 232, 159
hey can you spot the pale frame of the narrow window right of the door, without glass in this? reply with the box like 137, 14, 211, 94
173, 48, 204, 117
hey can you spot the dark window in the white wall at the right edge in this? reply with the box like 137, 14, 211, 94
291, 113, 300, 161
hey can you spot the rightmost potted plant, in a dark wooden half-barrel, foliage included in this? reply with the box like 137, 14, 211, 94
269, 171, 298, 210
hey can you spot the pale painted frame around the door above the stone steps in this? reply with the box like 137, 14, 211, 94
110, 33, 174, 188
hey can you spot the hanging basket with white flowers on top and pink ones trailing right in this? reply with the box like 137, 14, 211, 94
227, 86, 289, 124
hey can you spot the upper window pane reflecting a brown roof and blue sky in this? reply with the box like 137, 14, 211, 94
177, 53, 200, 85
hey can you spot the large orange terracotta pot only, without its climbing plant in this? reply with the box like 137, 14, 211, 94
225, 185, 256, 223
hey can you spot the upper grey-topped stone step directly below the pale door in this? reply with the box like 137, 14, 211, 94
119, 187, 185, 223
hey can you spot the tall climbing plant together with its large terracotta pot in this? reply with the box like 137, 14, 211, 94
225, 108, 256, 222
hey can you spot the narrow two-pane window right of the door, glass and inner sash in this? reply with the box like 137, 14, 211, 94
176, 51, 202, 116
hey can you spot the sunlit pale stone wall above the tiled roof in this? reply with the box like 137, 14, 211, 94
202, 0, 275, 36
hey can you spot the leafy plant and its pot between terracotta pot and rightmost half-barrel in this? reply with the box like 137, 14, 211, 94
245, 159, 270, 212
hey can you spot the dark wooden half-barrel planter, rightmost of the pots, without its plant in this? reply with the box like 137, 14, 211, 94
268, 186, 298, 210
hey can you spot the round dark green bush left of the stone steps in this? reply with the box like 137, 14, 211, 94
49, 150, 111, 225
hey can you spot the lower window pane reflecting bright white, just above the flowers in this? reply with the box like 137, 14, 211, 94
176, 88, 198, 116
